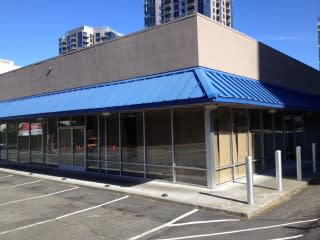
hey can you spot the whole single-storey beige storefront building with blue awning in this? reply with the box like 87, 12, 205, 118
0, 14, 320, 188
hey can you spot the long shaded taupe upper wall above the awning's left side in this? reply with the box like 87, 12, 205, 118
0, 16, 198, 99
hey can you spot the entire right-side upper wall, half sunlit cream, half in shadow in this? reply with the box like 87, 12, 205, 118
197, 15, 320, 94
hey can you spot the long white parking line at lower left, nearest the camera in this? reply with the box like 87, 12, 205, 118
0, 196, 129, 235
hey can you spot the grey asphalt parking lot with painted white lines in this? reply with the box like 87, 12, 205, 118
0, 173, 318, 240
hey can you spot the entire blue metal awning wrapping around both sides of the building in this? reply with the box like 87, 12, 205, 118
0, 67, 320, 119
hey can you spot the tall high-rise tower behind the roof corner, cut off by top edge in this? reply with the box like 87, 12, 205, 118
144, 0, 233, 27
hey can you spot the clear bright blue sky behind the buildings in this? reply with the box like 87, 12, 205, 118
0, 0, 320, 69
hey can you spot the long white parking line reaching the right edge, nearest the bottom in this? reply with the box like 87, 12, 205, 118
158, 218, 320, 240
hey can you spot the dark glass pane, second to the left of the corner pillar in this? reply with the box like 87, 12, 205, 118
145, 110, 172, 181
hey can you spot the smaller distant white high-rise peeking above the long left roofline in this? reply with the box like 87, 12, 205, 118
59, 26, 123, 55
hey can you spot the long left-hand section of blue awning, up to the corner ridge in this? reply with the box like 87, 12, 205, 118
0, 70, 207, 119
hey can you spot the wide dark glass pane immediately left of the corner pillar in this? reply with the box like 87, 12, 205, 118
174, 108, 207, 185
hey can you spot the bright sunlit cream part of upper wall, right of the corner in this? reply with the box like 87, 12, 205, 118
197, 15, 259, 79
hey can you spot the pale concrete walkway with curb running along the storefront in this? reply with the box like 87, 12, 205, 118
0, 168, 308, 218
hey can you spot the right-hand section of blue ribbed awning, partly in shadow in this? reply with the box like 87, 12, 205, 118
195, 68, 320, 111
